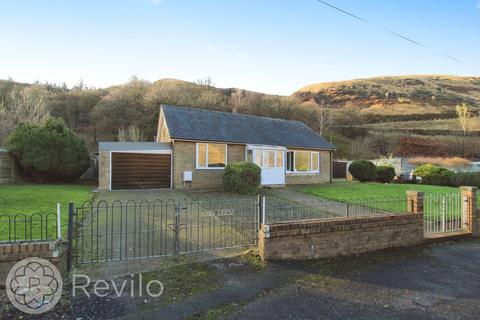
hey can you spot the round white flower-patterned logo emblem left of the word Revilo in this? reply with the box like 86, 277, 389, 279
5, 258, 63, 314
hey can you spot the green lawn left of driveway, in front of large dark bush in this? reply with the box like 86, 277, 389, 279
0, 184, 93, 241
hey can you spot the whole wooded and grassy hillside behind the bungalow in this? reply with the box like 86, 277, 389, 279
0, 75, 480, 159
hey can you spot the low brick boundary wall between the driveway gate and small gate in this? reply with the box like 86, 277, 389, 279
259, 214, 423, 260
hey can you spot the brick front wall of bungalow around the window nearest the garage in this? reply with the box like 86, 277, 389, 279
173, 140, 245, 189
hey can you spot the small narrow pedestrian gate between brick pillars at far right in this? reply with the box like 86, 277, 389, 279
423, 193, 471, 235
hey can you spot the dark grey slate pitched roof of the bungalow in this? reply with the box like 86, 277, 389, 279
161, 105, 335, 150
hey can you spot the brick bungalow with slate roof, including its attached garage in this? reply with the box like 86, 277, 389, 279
99, 105, 335, 190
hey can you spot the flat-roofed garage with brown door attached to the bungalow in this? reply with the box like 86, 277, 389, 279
99, 142, 172, 190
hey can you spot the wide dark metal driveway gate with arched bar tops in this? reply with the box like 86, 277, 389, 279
71, 198, 259, 264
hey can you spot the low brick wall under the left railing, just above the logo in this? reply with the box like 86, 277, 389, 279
0, 241, 67, 288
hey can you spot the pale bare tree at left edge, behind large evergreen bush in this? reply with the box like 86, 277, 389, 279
0, 85, 50, 145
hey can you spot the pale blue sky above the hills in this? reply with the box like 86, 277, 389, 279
0, 0, 480, 95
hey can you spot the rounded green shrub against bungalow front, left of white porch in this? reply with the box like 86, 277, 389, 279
223, 162, 261, 194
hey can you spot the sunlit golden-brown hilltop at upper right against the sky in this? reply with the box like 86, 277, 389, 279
293, 75, 480, 120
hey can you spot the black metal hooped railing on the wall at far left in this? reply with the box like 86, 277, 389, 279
0, 213, 57, 243
